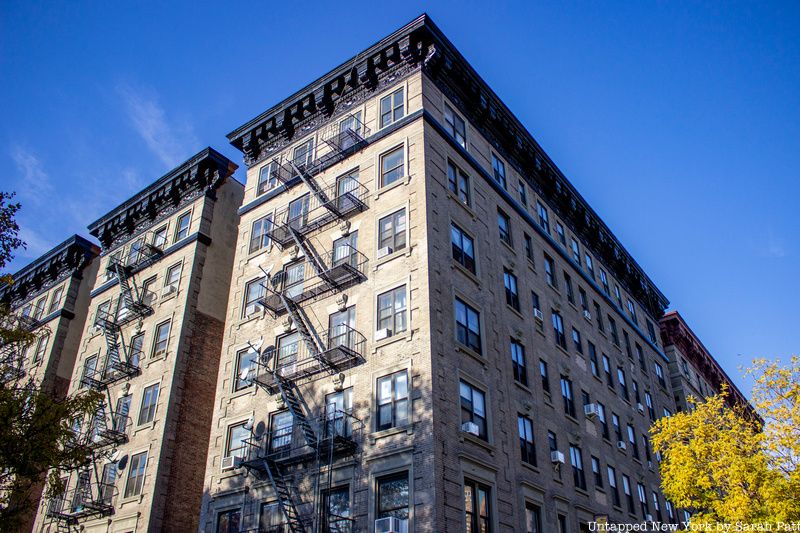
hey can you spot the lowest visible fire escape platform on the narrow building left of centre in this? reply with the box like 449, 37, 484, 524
46, 480, 116, 525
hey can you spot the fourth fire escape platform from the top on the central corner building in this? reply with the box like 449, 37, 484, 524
254, 325, 366, 394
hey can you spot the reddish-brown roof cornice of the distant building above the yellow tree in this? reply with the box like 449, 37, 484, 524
659, 311, 755, 413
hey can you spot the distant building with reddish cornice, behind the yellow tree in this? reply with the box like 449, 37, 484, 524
659, 311, 758, 418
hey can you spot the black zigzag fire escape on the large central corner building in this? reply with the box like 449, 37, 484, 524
240, 116, 368, 533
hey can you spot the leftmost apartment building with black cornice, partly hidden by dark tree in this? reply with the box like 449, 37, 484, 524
0, 235, 100, 530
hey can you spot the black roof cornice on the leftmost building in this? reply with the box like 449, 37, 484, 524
0, 235, 100, 308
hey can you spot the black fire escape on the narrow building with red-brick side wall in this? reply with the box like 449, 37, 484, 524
46, 240, 162, 531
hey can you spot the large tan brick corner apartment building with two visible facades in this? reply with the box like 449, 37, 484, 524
200, 15, 677, 533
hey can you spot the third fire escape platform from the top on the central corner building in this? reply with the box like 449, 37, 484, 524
259, 246, 367, 316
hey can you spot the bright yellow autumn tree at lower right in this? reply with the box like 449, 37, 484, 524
651, 376, 800, 523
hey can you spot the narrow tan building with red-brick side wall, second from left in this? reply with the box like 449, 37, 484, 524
34, 148, 243, 532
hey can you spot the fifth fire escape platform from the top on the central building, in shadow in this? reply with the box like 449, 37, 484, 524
239, 409, 364, 472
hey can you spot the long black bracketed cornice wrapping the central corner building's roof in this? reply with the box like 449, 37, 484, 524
228, 14, 669, 319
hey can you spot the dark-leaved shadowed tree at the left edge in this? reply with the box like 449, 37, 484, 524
0, 192, 102, 531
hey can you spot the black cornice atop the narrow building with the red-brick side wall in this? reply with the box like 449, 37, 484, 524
88, 144, 238, 246
